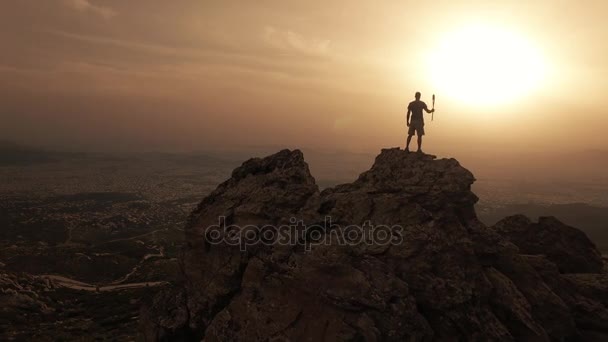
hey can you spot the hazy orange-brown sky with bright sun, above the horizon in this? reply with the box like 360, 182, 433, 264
0, 0, 608, 155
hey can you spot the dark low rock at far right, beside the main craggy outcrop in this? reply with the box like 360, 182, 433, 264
493, 215, 604, 273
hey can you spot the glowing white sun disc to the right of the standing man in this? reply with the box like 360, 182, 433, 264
428, 25, 545, 106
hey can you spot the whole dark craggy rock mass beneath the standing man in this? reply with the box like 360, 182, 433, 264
141, 149, 608, 341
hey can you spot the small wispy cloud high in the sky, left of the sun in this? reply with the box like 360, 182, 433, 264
264, 26, 331, 56
